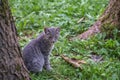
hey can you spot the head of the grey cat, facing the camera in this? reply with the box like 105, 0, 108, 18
44, 27, 60, 43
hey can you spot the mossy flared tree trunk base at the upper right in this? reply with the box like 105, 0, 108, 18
75, 0, 120, 39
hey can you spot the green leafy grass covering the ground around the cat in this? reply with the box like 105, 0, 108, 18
9, 0, 120, 80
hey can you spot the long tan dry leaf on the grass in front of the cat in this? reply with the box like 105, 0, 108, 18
61, 55, 86, 69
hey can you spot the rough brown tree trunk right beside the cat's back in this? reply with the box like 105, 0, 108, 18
0, 0, 30, 80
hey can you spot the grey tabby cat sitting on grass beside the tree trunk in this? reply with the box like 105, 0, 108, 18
23, 27, 60, 72
